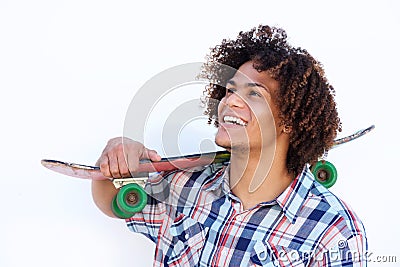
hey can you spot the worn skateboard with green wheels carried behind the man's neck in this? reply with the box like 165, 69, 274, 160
41, 125, 375, 219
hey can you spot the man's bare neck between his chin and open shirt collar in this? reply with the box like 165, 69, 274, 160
229, 147, 293, 209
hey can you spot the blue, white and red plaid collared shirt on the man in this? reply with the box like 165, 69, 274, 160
126, 164, 367, 267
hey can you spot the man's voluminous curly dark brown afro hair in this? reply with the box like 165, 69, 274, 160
201, 25, 341, 174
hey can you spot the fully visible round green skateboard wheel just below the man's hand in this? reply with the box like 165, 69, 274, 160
117, 184, 147, 213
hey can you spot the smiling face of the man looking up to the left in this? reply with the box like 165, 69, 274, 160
215, 61, 279, 151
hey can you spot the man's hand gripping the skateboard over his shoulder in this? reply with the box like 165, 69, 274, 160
96, 137, 161, 178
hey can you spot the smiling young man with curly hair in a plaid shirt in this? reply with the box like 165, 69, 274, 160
93, 26, 367, 266
